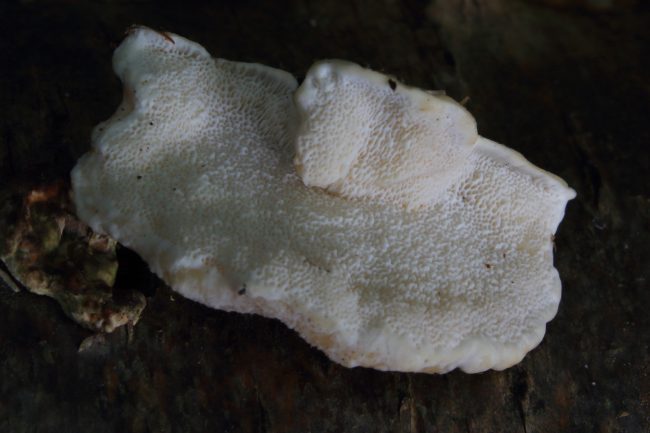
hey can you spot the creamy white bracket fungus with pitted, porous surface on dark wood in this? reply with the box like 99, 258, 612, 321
72, 28, 575, 372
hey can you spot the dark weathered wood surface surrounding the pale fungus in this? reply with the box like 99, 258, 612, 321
0, 0, 650, 433
